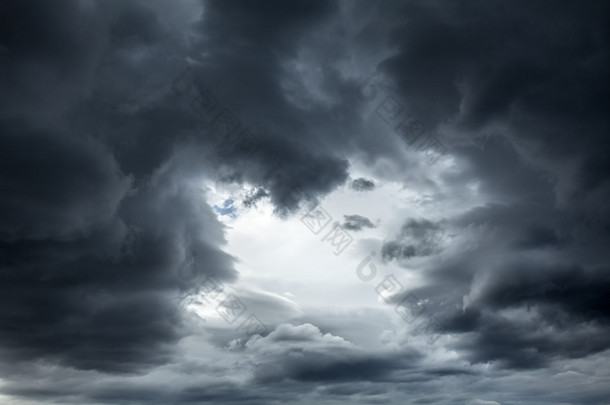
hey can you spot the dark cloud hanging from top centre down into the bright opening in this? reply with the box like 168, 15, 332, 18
170, 1, 347, 213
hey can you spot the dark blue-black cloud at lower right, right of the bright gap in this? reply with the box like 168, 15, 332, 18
384, 243, 610, 369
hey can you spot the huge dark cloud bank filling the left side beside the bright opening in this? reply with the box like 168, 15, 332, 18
0, 1, 234, 372
